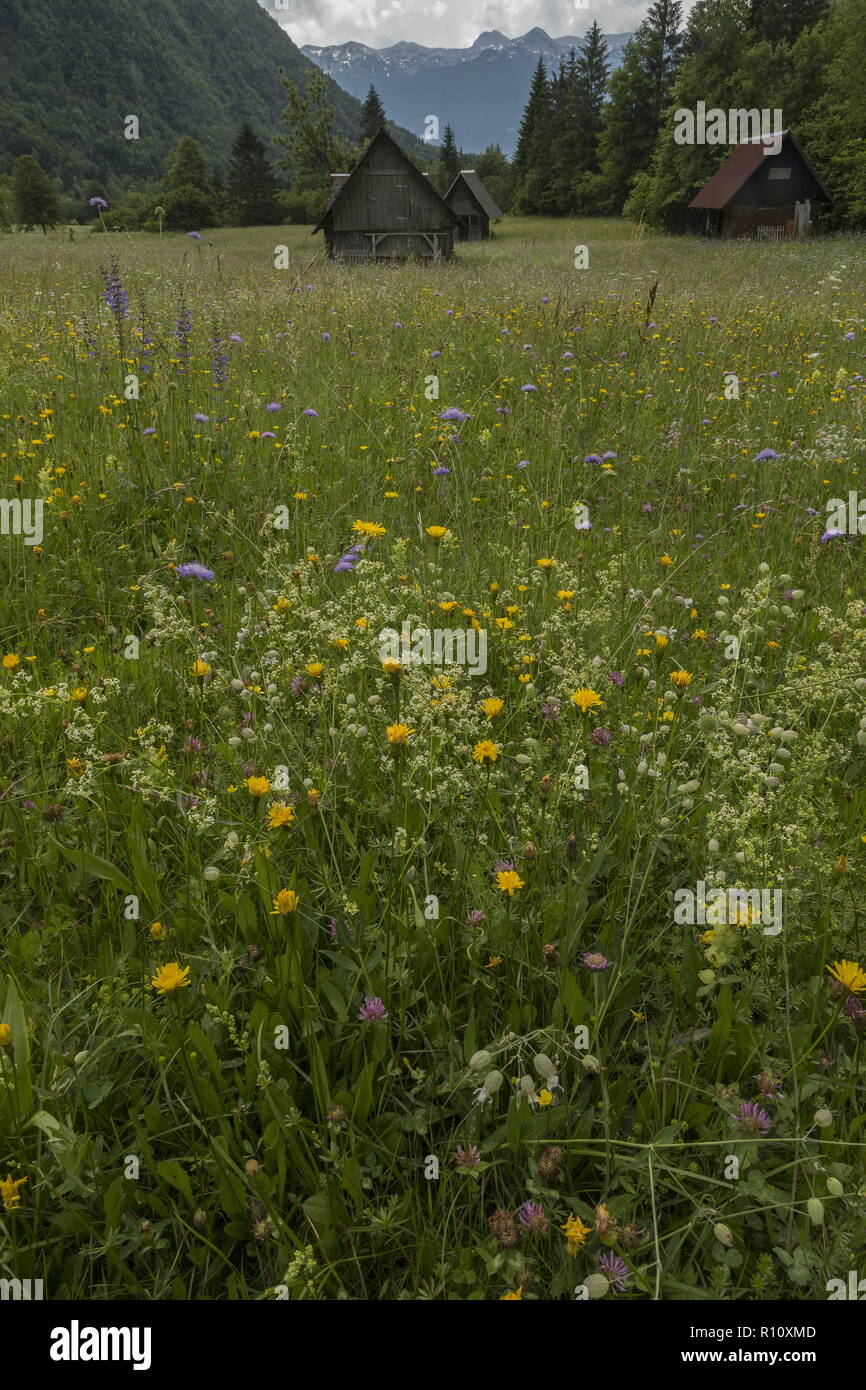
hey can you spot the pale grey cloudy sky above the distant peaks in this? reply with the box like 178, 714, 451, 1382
259, 0, 692, 49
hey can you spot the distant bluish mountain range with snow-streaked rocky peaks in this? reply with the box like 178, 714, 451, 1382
300, 28, 631, 157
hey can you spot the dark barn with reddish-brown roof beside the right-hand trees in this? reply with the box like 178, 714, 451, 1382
689, 131, 833, 240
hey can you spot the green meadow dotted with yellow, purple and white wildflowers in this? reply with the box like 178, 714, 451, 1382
0, 220, 866, 1301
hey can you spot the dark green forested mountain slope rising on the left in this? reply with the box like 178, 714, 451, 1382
0, 0, 424, 192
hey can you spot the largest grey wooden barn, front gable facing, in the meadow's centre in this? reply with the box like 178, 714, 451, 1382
313, 129, 457, 261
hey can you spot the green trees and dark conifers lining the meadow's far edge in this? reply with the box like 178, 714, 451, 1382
0, 0, 866, 231
